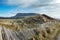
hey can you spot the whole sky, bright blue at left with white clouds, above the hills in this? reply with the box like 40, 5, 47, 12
0, 0, 60, 18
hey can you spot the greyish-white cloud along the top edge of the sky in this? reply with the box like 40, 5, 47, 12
6, 0, 54, 7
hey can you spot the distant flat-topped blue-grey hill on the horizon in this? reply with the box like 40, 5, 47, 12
0, 13, 38, 19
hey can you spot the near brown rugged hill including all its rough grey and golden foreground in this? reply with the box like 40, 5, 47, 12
0, 14, 60, 40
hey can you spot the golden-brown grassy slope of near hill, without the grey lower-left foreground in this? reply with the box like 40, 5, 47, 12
0, 15, 60, 40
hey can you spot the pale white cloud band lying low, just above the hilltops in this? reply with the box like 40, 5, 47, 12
6, 4, 60, 18
